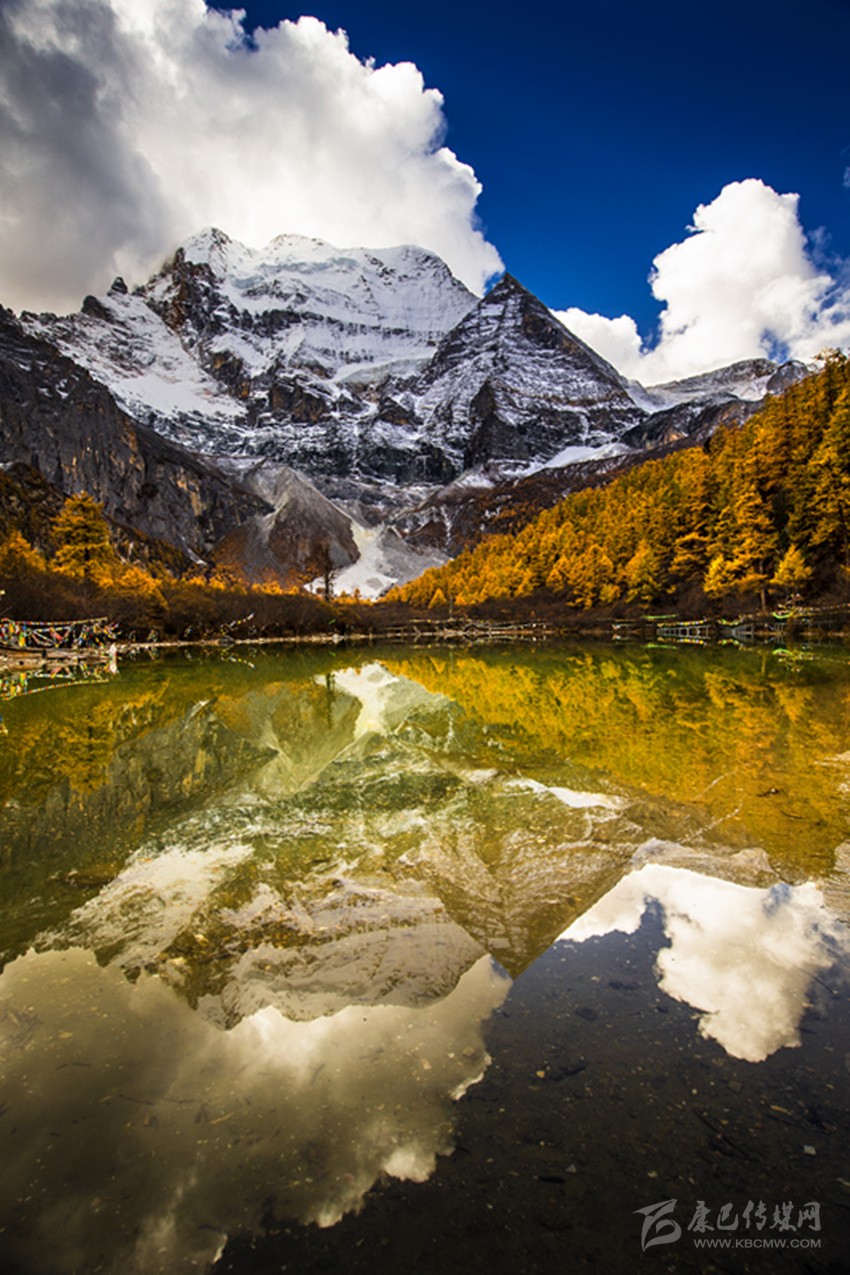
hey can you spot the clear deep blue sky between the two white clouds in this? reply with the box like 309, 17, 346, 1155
229, 0, 850, 333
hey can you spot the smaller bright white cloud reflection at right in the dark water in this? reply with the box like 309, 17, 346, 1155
562, 864, 847, 1062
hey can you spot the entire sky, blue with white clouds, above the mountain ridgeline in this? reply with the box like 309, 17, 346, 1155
0, 0, 850, 384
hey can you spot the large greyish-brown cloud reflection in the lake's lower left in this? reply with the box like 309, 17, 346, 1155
0, 949, 508, 1275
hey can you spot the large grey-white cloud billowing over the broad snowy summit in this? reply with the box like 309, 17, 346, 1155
0, 0, 501, 309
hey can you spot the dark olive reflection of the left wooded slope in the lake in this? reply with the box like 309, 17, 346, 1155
0, 682, 273, 952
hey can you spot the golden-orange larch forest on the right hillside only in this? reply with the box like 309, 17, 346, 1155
390, 351, 850, 608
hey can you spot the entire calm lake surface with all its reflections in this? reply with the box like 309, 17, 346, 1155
0, 645, 850, 1275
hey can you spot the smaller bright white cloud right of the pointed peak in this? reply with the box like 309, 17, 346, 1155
557, 179, 850, 385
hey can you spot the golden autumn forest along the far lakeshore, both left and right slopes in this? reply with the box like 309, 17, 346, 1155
0, 352, 850, 638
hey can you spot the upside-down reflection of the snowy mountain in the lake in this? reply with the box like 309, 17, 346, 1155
41, 664, 642, 1009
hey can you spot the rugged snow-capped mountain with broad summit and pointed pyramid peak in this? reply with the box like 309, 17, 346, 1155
0, 230, 805, 593
